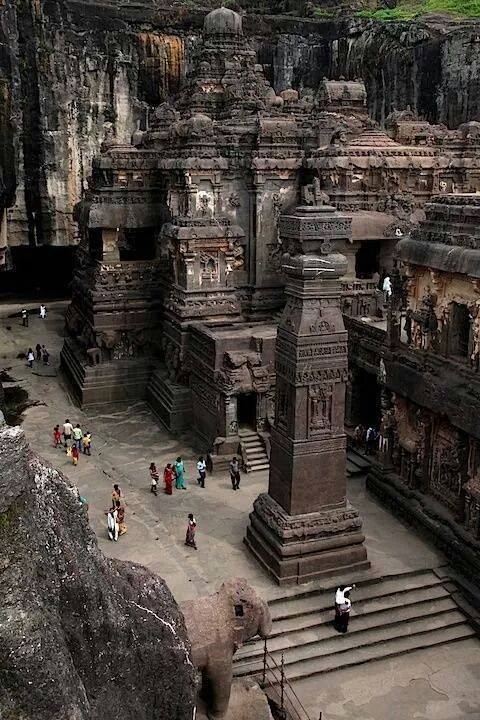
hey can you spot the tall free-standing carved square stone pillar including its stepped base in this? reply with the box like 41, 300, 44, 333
245, 206, 370, 585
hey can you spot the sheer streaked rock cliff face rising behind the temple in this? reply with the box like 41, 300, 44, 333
0, 0, 480, 252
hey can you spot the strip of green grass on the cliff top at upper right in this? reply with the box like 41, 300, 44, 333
357, 0, 480, 22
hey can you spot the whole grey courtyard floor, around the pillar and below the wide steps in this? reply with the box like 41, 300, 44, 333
0, 302, 480, 720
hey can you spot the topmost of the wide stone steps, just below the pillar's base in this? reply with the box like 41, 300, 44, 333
269, 570, 447, 621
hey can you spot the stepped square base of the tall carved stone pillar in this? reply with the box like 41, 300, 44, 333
245, 493, 370, 585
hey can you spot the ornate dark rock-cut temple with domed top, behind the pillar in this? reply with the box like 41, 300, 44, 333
62, 8, 480, 466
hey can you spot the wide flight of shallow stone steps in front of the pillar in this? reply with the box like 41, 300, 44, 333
234, 570, 476, 681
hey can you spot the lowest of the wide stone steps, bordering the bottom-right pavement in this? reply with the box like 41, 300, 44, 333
234, 609, 474, 678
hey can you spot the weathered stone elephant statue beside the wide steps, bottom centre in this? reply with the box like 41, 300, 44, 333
180, 578, 272, 720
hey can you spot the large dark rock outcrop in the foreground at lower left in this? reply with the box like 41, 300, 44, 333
0, 426, 195, 720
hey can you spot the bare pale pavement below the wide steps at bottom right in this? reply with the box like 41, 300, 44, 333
295, 639, 480, 720
